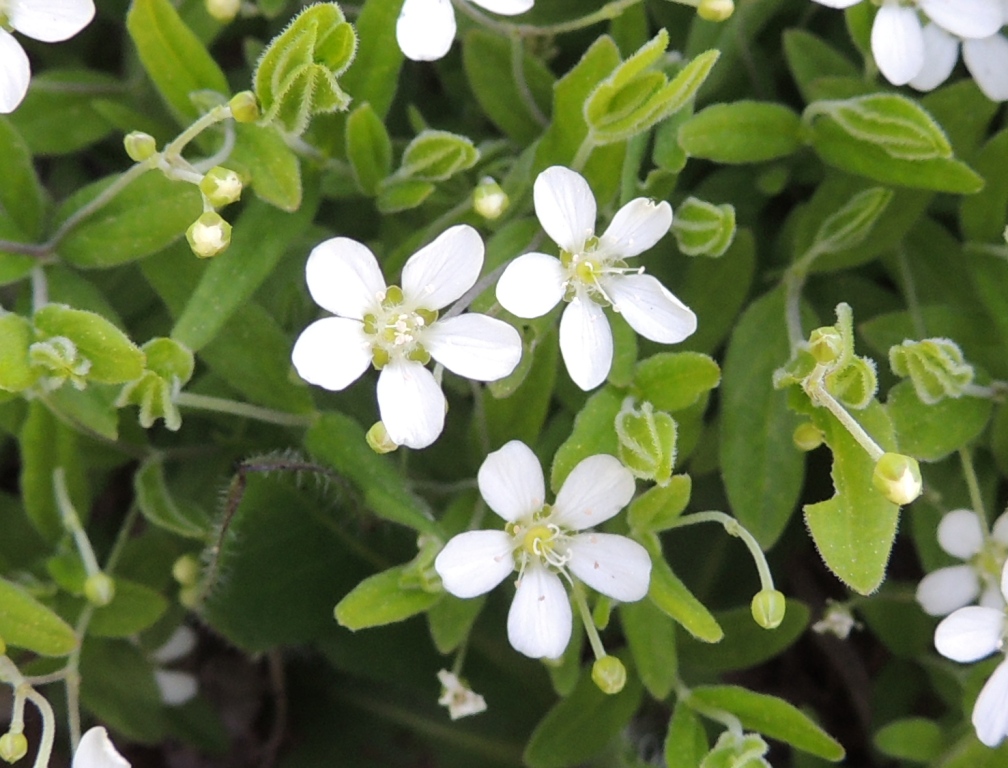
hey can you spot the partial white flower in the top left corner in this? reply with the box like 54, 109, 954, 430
0, 0, 95, 115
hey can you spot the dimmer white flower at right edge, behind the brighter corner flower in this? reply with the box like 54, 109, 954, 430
917, 509, 1008, 616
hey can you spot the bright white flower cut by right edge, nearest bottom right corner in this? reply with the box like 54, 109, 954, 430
934, 567, 1008, 747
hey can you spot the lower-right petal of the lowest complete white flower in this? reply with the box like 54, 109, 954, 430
568, 533, 651, 603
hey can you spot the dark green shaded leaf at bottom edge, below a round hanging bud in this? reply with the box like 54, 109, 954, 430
522, 666, 643, 768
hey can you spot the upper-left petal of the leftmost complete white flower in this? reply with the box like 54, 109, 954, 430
304, 237, 385, 319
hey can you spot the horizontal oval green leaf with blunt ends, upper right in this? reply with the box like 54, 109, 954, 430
679, 101, 803, 163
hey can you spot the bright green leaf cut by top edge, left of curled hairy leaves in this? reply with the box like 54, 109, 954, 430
126, 0, 231, 122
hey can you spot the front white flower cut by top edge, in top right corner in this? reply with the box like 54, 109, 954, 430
815, 0, 1004, 88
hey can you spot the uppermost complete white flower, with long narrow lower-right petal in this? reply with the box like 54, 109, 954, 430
497, 165, 697, 390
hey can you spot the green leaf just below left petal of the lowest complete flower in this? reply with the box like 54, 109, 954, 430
335, 565, 442, 632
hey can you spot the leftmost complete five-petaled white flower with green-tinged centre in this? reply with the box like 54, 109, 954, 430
291, 225, 521, 449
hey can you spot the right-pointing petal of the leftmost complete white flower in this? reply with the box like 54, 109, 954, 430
422, 312, 521, 381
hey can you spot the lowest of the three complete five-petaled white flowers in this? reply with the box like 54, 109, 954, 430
434, 440, 651, 658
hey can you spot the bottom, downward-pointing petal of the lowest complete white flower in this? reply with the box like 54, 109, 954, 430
507, 561, 573, 659
